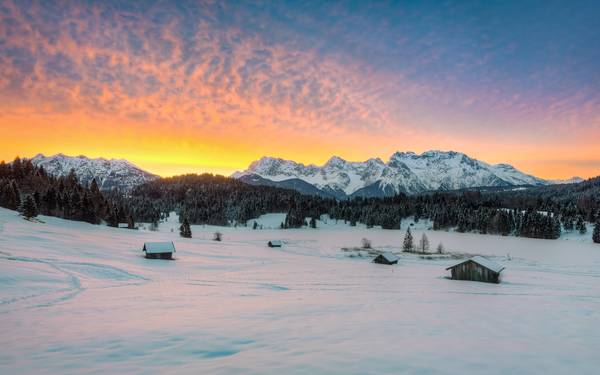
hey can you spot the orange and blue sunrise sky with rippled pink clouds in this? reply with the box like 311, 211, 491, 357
0, 0, 600, 178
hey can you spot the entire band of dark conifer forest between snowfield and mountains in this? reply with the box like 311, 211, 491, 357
0, 158, 600, 241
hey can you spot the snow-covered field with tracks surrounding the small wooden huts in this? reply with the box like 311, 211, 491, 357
0, 209, 600, 375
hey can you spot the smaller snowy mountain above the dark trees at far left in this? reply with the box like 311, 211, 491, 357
31, 154, 159, 190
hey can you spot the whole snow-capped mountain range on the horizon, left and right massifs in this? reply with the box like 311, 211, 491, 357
31, 151, 582, 199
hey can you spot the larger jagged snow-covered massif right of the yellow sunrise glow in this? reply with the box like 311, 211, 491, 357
233, 151, 549, 198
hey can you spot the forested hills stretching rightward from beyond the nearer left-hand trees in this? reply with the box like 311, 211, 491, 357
128, 175, 600, 239
